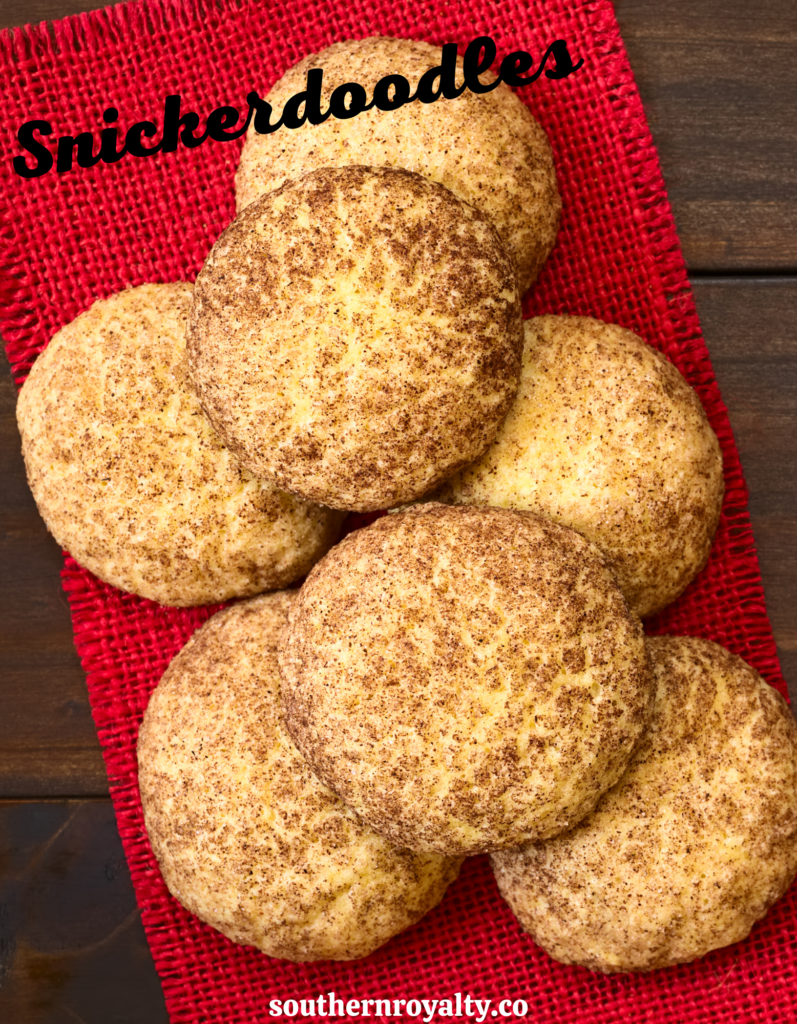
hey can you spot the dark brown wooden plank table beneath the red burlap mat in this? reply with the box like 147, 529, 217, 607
0, 0, 797, 1024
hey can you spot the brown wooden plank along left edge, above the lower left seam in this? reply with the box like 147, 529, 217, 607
0, 354, 108, 797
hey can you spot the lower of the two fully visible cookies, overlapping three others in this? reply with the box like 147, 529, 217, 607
280, 504, 651, 856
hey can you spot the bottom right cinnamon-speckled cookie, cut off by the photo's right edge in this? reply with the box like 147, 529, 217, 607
493, 637, 797, 973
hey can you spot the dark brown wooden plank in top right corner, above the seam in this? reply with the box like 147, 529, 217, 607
615, 0, 797, 272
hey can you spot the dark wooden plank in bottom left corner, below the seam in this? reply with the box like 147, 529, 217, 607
0, 800, 168, 1024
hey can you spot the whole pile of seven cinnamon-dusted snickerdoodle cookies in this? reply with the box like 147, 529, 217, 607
13, 38, 797, 972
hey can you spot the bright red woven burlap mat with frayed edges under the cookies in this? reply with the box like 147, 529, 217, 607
0, 0, 797, 1024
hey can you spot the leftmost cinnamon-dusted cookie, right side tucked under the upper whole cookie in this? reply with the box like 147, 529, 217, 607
17, 283, 341, 605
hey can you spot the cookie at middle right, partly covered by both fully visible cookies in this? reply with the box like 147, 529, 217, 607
435, 316, 724, 616
